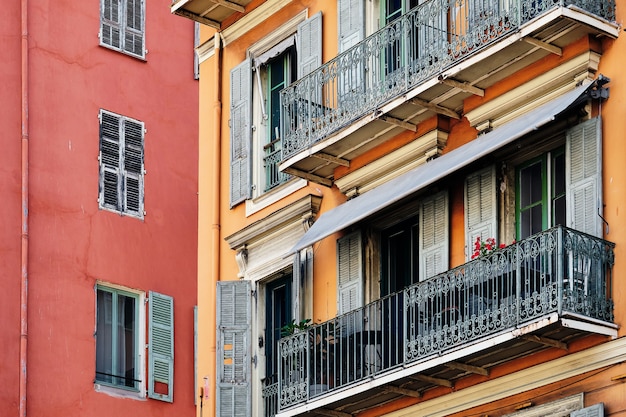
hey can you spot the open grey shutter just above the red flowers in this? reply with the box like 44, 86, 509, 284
465, 166, 497, 260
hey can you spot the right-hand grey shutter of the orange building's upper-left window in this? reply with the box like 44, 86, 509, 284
296, 12, 322, 78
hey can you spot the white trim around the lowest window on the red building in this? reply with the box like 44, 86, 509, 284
93, 281, 147, 400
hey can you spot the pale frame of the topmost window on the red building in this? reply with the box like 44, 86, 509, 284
99, 0, 146, 60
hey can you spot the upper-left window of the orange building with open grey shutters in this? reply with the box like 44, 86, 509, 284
230, 13, 322, 207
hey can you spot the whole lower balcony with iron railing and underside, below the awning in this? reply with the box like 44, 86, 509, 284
264, 226, 617, 416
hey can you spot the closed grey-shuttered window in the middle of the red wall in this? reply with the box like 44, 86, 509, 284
98, 110, 144, 218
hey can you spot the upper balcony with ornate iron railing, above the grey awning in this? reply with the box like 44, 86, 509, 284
280, 0, 619, 185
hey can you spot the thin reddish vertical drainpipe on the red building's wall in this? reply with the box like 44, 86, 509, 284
19, 0, 28, 417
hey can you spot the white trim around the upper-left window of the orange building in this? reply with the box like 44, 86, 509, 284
246, 9, 309, 203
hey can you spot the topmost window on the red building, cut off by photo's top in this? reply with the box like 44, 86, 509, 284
100, 0, 145, 58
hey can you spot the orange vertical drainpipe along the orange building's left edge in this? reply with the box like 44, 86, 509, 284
209, 32, 222, 416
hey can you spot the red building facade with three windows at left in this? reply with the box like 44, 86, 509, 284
0, 0, 198, 416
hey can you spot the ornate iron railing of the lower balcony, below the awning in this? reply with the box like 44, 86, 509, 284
274, 226, 615, 410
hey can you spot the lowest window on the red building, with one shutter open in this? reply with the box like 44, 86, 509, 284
95, 284, 174, 402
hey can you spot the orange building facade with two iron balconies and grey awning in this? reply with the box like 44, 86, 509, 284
171, 0, 626, 417
